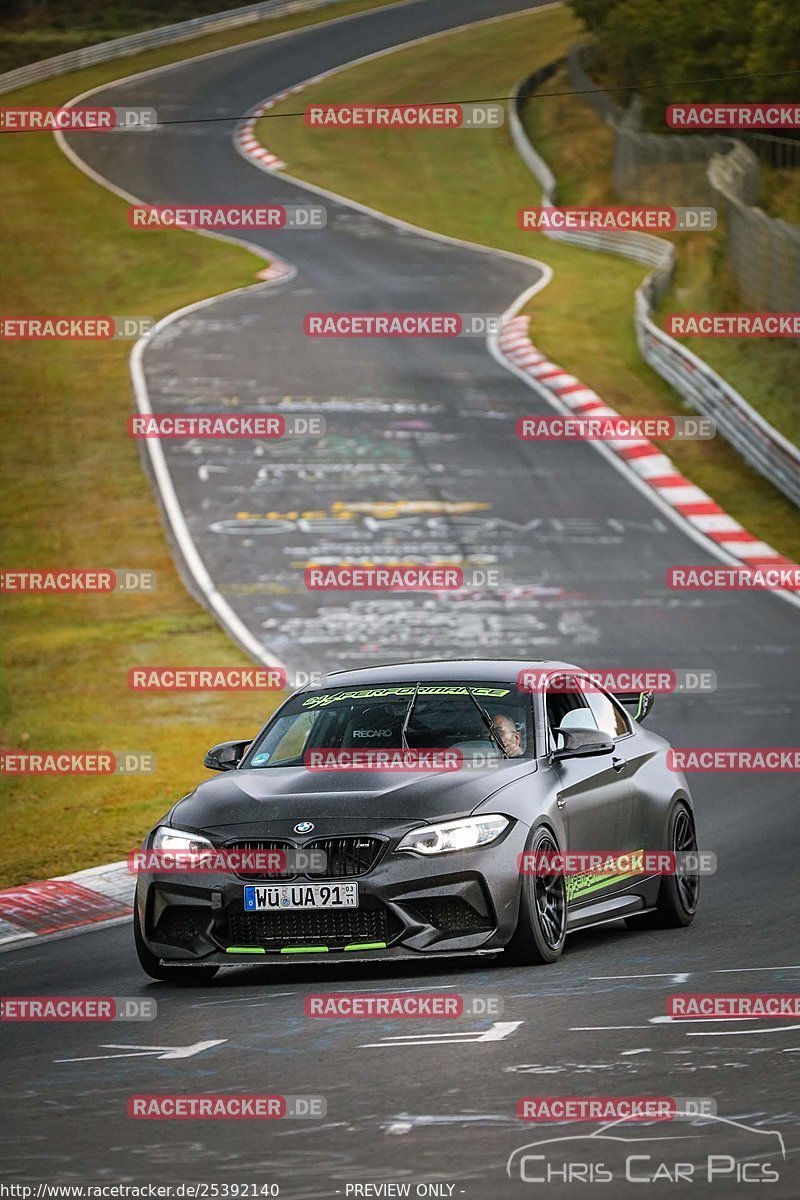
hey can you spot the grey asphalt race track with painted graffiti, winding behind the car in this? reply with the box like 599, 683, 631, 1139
0, 0, 800, 1200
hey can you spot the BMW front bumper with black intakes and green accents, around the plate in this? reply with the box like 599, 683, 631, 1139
137, 822, 529, 966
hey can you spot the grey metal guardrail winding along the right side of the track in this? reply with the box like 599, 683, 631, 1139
509, 60, 800, 508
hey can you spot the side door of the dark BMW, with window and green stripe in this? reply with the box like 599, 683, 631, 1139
545, 677, 632, 904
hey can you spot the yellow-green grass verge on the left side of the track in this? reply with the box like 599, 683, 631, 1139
0, 4, 400, 886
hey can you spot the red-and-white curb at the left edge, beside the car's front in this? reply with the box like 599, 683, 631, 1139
0, 860, 136, 948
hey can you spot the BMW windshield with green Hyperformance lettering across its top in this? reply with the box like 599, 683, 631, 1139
242, 682, 534, 768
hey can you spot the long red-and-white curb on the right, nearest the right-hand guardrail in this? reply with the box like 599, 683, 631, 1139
498, 316, 795, 580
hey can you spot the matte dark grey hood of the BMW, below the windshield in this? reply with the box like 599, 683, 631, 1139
170, 758, 536, 836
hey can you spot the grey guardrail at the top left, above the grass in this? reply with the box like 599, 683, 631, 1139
0, 0, 342, 94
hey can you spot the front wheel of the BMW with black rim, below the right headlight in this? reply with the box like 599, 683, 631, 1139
505, 827, 566, 966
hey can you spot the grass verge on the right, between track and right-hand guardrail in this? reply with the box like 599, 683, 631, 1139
258, 8, 800, 558
